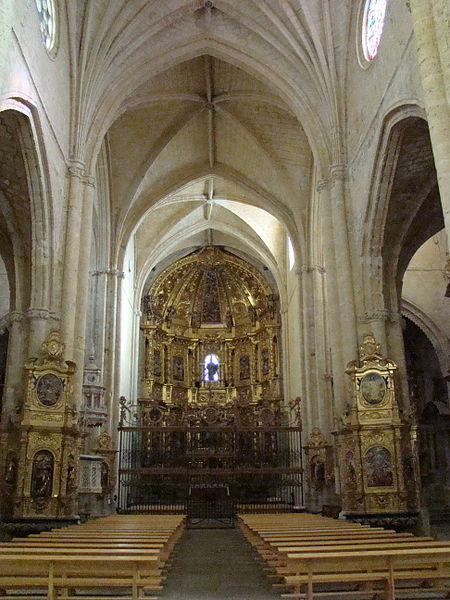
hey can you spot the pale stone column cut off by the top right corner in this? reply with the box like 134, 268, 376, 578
410, 0, 450, 239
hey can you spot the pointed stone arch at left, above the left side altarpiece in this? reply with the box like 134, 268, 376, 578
0, 99, 53, 311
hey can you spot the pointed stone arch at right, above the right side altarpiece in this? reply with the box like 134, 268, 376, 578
361, 104, 443, 313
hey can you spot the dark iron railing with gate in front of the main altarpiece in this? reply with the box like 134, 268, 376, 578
118, 419, 303, 519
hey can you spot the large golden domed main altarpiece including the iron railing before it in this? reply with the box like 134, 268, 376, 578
119, 246, 301, 512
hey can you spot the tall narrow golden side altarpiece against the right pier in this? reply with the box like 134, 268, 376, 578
336, 334, 418, 525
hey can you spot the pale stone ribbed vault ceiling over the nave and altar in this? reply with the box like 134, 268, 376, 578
82, 0, 342, 280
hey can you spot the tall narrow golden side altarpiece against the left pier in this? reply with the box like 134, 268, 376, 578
4, 331, 80, 520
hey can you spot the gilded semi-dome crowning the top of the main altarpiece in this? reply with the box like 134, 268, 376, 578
142, 247, 276, 333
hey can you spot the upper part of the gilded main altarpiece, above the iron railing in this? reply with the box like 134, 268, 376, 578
141, 247, 281, 406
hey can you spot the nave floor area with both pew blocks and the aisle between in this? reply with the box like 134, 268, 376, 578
0, 513, 450, 600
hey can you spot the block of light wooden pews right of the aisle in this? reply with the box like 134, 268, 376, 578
238, 513, 450, 600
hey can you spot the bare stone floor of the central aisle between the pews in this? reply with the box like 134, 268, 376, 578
160, 529, 280, 600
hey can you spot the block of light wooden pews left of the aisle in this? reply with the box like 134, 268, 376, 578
0, 515, 185, 600
